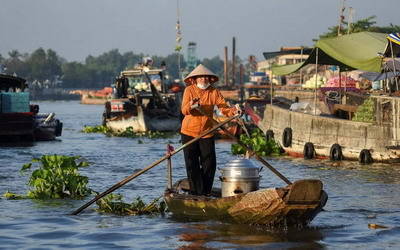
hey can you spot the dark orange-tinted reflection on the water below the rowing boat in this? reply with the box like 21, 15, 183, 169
175, 221, 323, 249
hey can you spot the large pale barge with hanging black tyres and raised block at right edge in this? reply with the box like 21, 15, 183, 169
258, 96, 400, 163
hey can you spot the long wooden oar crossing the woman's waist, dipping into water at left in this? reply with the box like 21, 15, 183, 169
71, 115, 240, 215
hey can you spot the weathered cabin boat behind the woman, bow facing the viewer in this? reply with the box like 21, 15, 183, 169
103, 59, 181, 132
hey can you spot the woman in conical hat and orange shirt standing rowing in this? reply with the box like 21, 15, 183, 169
181, 64, 241, 195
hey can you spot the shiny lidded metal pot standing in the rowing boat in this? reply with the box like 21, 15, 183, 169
219, 159, 261, 197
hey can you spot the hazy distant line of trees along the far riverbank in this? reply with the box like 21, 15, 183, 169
0, 48, 228, 89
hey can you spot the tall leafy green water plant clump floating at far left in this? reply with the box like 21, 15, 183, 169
21, 155, 90, 199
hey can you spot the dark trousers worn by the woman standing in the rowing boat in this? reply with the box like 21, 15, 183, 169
182, 134, 217, 195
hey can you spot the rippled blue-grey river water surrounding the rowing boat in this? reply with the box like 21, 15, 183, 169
0, 101, 400, 249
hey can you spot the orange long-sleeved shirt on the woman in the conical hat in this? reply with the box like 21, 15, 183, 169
181, 84, 236, 138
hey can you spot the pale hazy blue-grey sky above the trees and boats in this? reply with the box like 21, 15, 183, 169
0, 0, 400, 61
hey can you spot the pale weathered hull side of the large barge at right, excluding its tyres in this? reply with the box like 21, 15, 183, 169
258, 105, 400, 163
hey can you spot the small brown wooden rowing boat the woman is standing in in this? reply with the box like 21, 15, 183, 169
164, 180, 328, 226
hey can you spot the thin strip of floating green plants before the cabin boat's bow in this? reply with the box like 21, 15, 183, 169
82, 125, 176, 140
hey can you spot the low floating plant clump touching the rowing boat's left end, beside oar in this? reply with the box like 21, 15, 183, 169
96, 194, 166, 215
